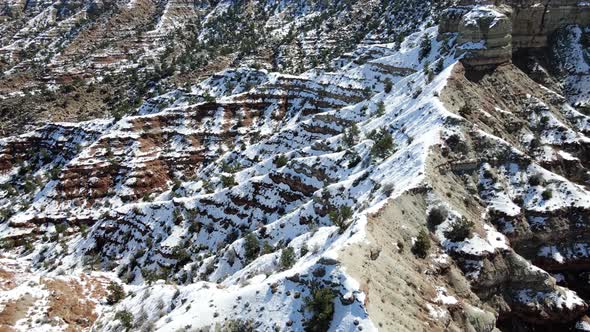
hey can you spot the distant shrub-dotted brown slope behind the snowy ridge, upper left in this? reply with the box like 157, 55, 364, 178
0, 0, 450, 136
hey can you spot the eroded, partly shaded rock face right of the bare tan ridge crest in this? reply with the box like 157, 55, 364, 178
442, 64, 589, 331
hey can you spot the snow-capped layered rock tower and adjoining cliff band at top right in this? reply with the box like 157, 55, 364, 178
440, 0, 590, 69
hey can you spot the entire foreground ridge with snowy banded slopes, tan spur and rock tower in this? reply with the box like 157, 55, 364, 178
0, 0, 590, 331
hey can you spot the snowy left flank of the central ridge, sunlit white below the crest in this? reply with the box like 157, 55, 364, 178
2, 25, 468, 330
